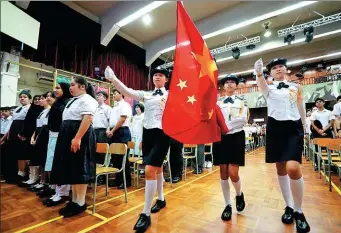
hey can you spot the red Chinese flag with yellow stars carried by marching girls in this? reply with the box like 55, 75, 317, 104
162, 2, 227, 144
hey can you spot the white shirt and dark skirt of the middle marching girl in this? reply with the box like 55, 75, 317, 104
213, 95, 247, 166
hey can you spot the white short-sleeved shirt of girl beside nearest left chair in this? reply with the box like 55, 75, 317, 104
63, 94, 98, 121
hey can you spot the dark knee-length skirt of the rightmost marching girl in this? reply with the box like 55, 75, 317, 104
265, 117, 304, 163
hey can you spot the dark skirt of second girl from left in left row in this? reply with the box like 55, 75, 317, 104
30, 125, 49, 167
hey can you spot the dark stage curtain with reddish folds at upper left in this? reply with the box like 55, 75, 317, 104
1, 1, 151, 90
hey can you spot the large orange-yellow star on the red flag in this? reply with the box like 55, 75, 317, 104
192, 43, 217, 87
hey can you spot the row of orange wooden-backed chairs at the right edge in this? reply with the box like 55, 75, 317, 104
304, 136, 341, 191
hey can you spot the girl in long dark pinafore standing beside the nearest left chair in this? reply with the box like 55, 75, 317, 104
51, 77, 98, 218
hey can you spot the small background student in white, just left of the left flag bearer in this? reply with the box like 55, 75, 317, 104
131, 103, 144, 155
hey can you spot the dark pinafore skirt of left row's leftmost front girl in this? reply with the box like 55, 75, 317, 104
8, 120, 32, 160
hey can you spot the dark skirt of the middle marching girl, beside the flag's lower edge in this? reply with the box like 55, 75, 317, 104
213, 130, 245, 166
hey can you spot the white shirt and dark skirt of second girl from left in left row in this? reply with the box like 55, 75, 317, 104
30, 108, 50, 167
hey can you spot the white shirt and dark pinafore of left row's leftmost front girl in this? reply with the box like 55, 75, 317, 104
4, 104, 30, 182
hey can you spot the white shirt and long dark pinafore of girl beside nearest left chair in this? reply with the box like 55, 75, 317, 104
51, 94, 98, 184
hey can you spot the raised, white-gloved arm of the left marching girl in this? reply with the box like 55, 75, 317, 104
105, 66, 143, 101
